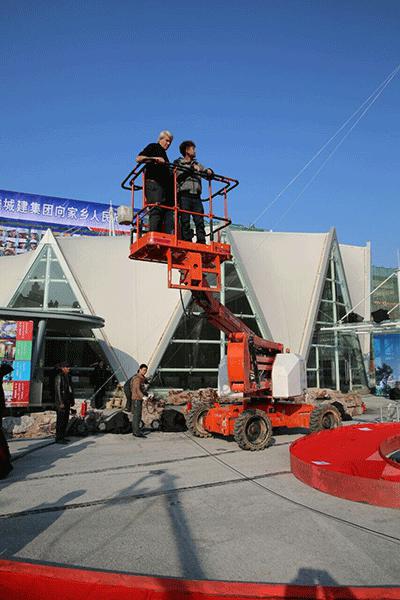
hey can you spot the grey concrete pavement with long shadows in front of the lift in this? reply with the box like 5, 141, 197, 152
0, 398, 400, 585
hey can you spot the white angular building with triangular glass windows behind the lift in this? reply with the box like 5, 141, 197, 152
0, 229, 370, 404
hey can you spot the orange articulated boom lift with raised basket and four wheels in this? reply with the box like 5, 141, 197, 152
118, 165, 340, 450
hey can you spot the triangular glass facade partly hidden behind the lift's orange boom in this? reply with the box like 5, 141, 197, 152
153, 262, 261, 390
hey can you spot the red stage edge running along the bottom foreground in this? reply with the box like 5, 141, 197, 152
0, 560, 400, 600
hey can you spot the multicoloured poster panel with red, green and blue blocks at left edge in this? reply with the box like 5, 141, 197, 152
0, 321, 33, 407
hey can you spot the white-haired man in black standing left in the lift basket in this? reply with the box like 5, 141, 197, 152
136, 129, 174, 233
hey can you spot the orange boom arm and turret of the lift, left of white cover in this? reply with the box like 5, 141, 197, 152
192, 291, 283, 397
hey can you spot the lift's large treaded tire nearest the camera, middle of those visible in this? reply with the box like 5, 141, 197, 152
233, 409, 272, 452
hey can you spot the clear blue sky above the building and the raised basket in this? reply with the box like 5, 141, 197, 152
0, 0, 400, 266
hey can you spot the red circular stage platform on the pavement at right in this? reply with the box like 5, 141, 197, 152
290, 423, 400, 508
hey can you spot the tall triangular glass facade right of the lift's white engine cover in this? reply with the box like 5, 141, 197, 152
307, 248, 367, 392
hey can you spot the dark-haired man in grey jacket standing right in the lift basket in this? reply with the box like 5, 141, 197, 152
174, 140, 214, 244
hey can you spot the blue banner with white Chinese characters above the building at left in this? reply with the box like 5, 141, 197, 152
0, 190, 129, 233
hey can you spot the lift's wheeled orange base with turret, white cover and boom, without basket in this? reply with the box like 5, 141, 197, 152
186, 291, 340, 451
